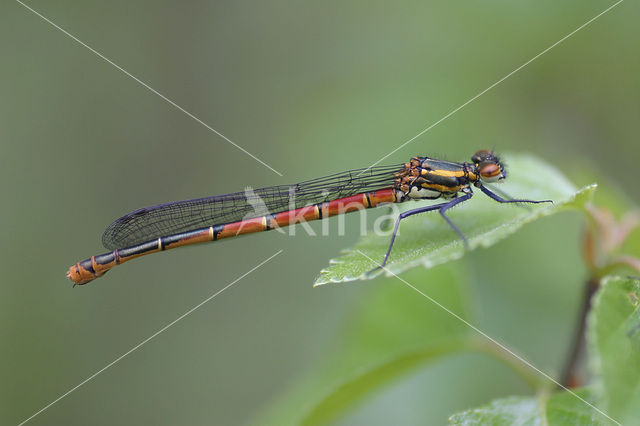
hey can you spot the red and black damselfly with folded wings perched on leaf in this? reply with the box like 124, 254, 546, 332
67, 150, 551, 284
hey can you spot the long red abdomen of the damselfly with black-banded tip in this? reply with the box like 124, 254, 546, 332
67, 189, 396, 285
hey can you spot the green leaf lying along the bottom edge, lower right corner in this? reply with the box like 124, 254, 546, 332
449, 388, 612, 426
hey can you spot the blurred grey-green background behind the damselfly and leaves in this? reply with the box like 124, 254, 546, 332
0, 0, 640, 425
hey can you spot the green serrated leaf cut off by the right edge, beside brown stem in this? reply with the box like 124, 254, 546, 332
587, 277, 640, 424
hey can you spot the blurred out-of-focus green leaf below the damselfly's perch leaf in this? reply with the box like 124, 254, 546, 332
254, 264, 471, 424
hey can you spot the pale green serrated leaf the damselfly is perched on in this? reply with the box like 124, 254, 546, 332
315, 154, 596, 285
